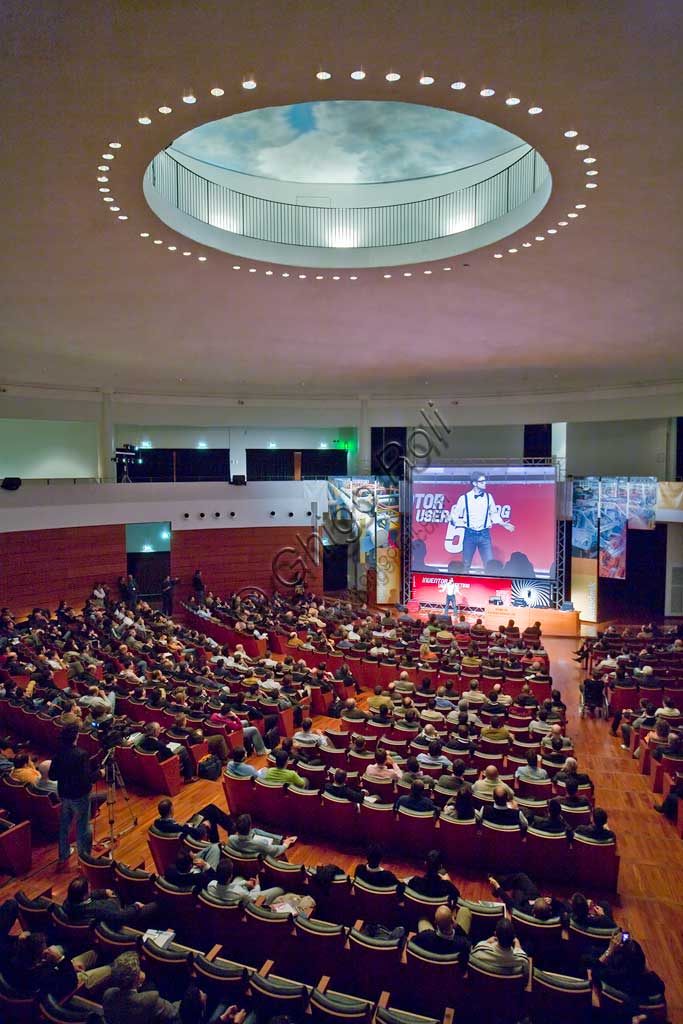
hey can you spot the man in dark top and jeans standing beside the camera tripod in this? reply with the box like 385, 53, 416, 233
49, 722, 103, 864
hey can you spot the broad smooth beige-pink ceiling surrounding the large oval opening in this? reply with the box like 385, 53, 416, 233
0, 0, 683, 399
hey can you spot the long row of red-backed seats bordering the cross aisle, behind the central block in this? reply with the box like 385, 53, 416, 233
223, 772, 620, 891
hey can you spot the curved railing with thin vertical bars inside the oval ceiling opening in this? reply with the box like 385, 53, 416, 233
144, 147, 550, 249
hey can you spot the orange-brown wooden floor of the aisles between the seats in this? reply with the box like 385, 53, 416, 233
0, 639, 683, 1024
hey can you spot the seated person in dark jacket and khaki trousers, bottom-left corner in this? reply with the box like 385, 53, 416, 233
10, 932, 112, 1000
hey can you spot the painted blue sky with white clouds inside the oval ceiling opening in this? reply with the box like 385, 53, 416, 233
173, 100, 522, 184
